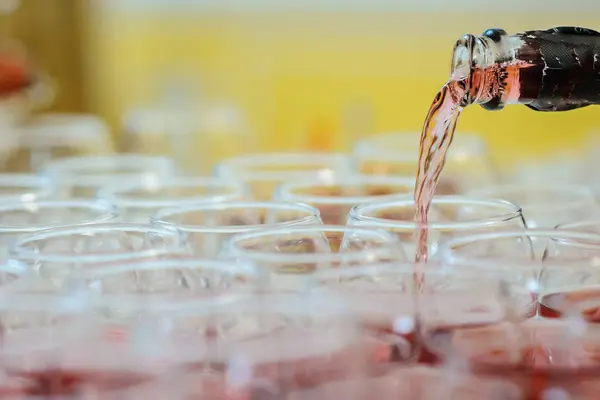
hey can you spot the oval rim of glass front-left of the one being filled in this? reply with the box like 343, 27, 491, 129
222, 225, 408, 265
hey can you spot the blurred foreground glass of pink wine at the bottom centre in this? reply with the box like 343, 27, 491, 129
115, 294, 368, 399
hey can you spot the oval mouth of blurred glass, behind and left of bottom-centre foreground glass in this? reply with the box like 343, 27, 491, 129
67, 256, 264, 303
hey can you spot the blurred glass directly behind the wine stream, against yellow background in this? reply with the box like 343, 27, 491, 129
353, 132, 498, 195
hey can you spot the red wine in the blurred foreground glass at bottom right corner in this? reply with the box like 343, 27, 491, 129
426, 320, 600, 400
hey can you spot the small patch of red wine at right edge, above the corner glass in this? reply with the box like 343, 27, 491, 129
540, 287, 600, 323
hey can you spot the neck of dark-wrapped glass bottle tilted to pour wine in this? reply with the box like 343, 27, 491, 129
452, 27, 600, 111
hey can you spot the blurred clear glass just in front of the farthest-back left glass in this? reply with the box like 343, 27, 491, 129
42, 154, 176, 198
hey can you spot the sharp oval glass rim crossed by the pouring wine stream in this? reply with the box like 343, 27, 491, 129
348, 195, 523, 231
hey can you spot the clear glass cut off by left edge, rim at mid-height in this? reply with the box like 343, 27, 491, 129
0, 200, 118, 259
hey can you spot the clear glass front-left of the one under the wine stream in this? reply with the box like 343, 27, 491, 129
222, 225, 407, 291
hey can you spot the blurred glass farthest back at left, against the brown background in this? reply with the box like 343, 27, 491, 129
3, 114, 112, 172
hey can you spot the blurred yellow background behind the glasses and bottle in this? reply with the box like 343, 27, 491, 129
8, 0, 600, 174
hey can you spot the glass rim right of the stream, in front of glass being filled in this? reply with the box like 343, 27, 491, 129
438, 228, 600, 268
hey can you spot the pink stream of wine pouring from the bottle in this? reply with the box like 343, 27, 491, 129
414, 78, 468, 263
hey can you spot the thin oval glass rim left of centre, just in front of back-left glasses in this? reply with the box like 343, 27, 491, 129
97, 177, 246, 208
